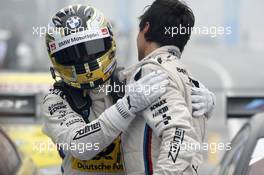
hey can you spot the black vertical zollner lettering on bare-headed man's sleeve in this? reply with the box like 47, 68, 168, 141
168, 128, 184, 163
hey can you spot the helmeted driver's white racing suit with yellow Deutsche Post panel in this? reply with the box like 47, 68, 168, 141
43, 90, 127, 175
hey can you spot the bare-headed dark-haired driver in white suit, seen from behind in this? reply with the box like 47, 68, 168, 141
122, 0, 211, 175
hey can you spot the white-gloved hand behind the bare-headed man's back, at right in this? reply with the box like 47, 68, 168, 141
191, 82, 216, 119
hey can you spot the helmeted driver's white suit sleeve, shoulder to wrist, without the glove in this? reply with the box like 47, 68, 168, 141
43, 90, 134, 160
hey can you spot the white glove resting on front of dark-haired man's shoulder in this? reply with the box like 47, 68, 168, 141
116, 69, 169, 118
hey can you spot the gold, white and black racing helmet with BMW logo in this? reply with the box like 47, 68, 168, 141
46, 5, 116, 89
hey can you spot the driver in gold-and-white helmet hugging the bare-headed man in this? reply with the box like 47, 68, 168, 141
43, 5, 214, 174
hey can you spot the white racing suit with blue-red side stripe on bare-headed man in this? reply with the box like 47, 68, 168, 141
121, 46, 207, 175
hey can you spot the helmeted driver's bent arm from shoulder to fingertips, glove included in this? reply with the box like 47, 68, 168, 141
43, 72, 168, 160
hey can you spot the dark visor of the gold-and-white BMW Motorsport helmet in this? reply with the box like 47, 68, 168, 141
53, 37, 112, 66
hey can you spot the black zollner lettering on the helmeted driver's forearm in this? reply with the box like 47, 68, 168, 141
73, 122, 101, 140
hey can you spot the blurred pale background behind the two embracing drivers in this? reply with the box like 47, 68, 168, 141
0, 0, 264, 175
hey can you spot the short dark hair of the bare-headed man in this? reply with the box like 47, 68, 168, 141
139, 0, 195, 52
